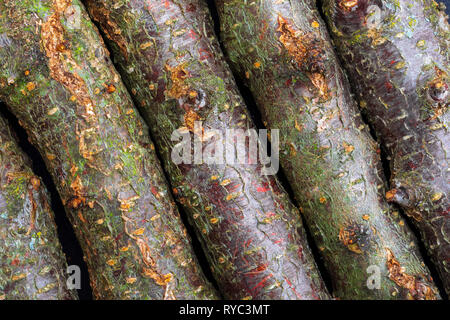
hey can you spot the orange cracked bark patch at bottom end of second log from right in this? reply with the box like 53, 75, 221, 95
385, 248, 437, 300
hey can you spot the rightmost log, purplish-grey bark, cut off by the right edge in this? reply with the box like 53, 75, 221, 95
324, 0, 450, 294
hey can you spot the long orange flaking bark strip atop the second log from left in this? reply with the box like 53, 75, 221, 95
41, 0, 94, 116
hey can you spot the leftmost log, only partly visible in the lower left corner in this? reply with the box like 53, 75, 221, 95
0, 117, 77, 300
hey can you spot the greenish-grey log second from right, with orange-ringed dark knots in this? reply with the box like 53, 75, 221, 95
217, 0, 439, 299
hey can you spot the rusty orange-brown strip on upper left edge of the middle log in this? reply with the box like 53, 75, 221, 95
87, 2, 128, 60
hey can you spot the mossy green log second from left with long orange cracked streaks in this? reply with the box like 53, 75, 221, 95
0, 0, 216, 299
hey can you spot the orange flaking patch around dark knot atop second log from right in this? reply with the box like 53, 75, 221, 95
277, 16, 328, 98
